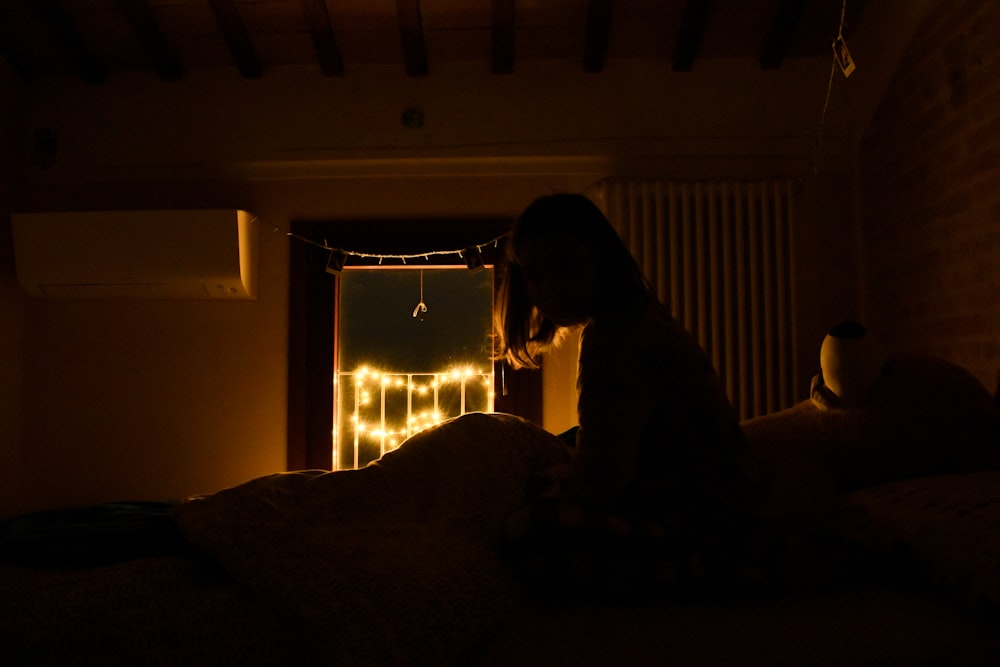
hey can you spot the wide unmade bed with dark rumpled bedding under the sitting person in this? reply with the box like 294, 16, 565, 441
0, 357, 1000, 667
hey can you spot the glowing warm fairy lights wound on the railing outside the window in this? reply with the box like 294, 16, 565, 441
333, 365, 494, 468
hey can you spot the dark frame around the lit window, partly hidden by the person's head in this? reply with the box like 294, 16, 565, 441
287, 218, 542, 470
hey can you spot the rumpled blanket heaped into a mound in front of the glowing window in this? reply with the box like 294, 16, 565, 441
175, 413, 568, 665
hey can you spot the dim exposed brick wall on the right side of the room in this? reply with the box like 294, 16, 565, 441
861, 0, 1000, 391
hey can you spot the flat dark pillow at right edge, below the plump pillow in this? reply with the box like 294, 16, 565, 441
835, 471, 1000, 610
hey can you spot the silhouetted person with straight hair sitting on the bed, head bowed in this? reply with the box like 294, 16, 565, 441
495, 194, 756, 594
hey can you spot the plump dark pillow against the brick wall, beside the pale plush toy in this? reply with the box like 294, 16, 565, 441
742, 355, 1000, 501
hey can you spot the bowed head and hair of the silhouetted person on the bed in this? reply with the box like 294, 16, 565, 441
496, 194, 650, 367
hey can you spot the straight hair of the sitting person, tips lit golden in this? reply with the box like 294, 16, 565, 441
494, 194, 656, 368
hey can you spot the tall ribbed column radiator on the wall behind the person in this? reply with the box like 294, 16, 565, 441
587, 179, 799, 419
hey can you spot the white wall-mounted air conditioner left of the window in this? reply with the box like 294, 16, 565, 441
11, 209, 257, 299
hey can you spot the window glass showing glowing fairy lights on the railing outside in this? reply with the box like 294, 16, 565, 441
333, 267, 493, 469
